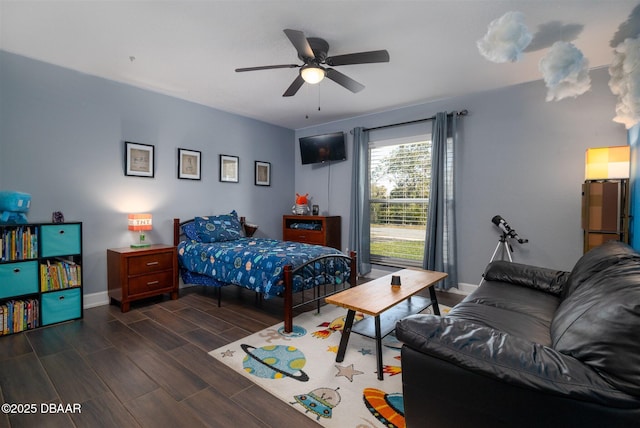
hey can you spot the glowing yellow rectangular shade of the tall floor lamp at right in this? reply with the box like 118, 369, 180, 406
584, 146, 630, 180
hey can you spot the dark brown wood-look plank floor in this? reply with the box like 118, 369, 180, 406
0, 280, 460, 428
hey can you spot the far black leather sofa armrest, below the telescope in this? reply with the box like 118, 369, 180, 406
483, 260, 569, 296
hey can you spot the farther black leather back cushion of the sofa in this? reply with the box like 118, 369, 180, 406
563, 241, 640, 297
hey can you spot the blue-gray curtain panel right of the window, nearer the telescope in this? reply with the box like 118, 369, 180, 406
422, 112, 458, 290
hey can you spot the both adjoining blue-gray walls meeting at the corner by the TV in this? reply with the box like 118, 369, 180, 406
0, 51, 627, 293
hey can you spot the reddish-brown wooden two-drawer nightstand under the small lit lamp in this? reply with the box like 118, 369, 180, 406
107, 244, 178, 312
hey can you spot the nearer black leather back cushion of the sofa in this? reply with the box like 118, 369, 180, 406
551, 262, 640, 396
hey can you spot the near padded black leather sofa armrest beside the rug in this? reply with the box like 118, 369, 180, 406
396, 314, 637, 406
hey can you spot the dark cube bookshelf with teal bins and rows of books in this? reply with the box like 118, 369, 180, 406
0, 222, 83, 336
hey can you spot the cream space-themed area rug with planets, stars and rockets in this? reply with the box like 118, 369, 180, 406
209, 305, 449, 428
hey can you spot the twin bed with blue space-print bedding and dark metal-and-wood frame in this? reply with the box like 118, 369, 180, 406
173, 211, 356, 333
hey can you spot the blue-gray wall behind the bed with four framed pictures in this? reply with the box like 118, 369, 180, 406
0, 51, 294, 300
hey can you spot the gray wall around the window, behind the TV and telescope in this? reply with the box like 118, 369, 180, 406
296, 69, 627, 284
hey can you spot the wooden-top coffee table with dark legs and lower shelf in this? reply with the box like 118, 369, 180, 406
325, 269, 447, 380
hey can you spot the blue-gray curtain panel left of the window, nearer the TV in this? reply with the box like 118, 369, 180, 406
349, 128, 371, 275
